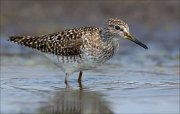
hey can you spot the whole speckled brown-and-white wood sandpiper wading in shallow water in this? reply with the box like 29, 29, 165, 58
9, 18, 148, 84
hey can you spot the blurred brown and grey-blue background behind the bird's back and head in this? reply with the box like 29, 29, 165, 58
0, 0, 179, 53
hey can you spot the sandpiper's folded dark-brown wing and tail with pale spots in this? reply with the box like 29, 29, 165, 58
9, 29, 82, 56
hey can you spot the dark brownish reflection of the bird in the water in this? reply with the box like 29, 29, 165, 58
38, 84, 113, 114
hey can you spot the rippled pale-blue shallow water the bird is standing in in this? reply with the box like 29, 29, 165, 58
1, 45, 180, 114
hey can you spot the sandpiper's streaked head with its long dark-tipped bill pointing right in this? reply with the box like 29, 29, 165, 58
106, 18, 148, 49
